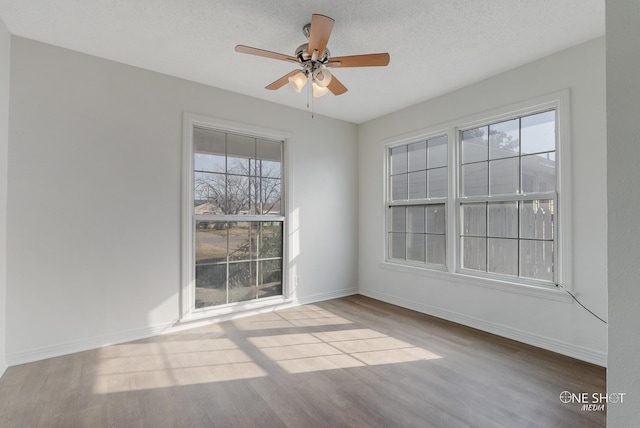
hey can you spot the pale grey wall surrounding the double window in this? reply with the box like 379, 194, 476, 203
359, 39, 607, 365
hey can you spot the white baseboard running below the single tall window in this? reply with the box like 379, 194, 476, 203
5, 287, 358, 366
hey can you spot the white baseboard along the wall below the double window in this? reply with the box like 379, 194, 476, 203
360, 288, 607, 367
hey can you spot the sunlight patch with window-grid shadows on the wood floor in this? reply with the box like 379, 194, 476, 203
93, 305, 441, 394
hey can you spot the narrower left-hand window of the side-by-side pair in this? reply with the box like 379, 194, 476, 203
387, 136, 448, 266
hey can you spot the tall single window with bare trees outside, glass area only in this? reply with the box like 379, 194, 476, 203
189, 126, 284, 310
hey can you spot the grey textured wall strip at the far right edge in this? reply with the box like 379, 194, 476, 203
606, 0, 640, 427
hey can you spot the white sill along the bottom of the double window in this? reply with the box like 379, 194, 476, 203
379, 261, 573, 303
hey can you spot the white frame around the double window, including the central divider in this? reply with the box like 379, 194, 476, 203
380, 89, 573, 301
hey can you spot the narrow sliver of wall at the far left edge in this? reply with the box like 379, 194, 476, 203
0, 18, 11, 376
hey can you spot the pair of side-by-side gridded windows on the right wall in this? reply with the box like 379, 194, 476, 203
385, 91, 571, 292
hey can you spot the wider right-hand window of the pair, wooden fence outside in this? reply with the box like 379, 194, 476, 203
459, 110, 557, 283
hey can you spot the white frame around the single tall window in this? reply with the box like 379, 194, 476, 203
180, 112, 291, 321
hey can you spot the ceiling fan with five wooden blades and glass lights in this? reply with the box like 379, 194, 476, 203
236, 14, 389, 97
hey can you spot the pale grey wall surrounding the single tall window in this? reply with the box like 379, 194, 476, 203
7, 37, 358, 364
